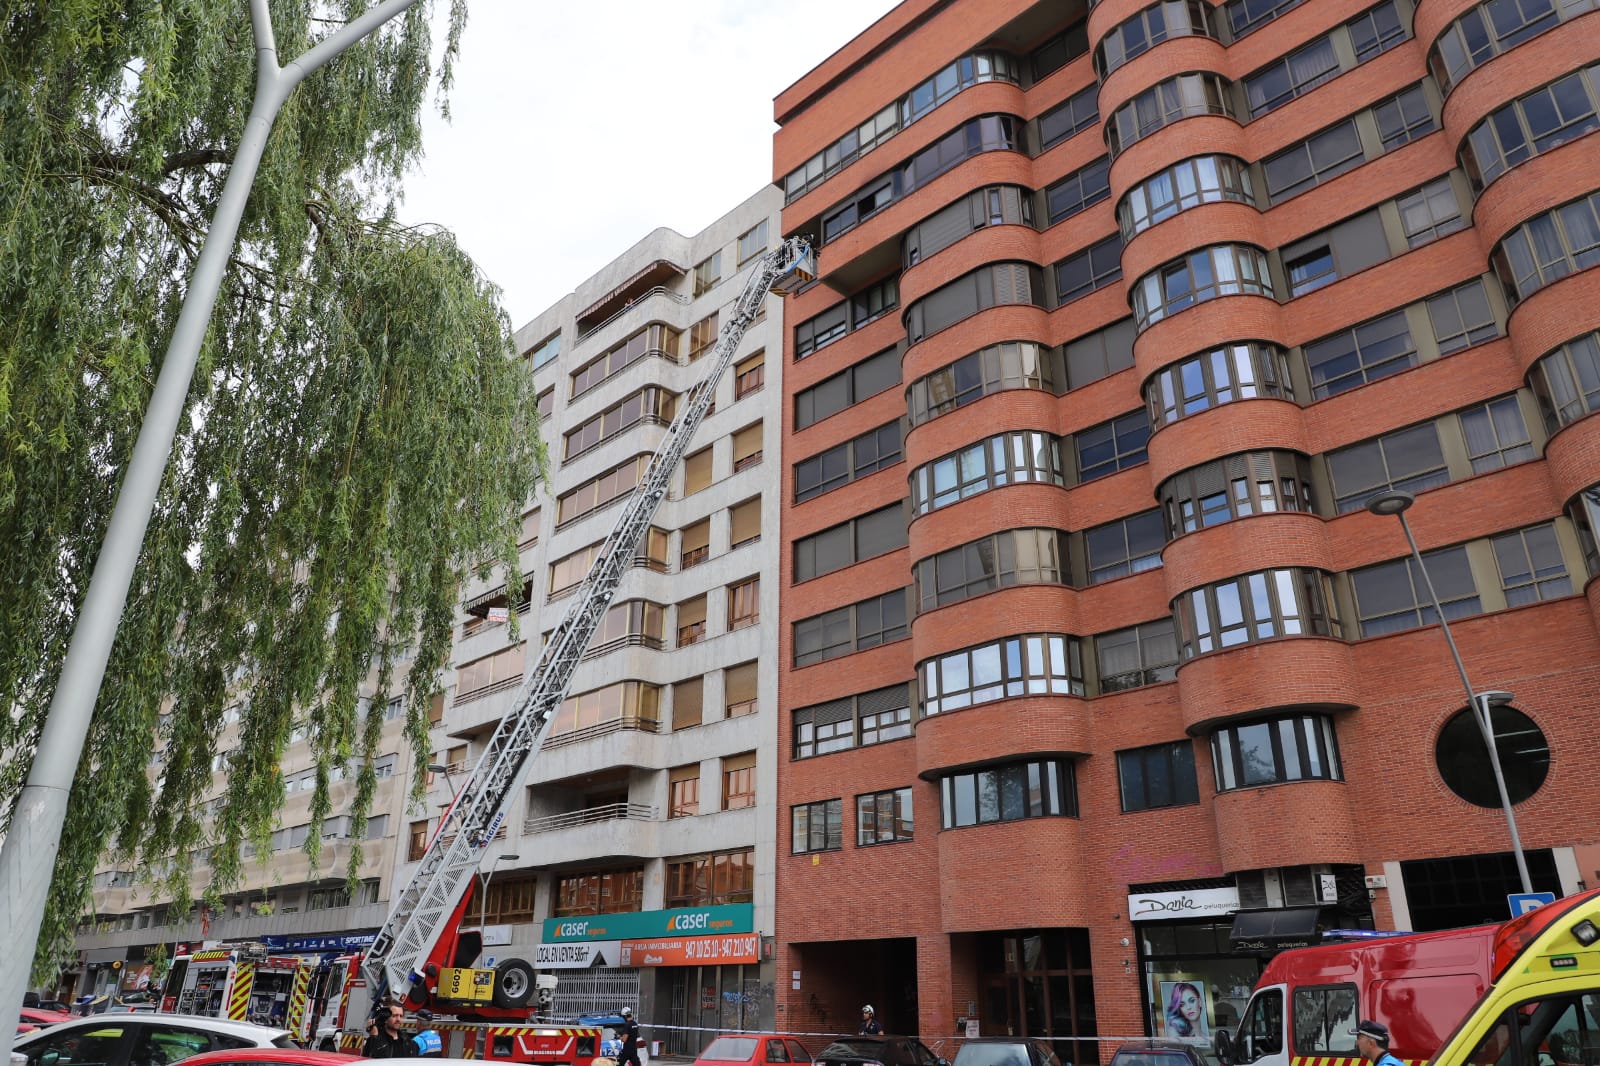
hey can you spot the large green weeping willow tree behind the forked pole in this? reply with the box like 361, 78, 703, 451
0, 0, 544, 972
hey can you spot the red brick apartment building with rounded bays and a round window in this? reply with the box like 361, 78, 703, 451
773, 0, 1600, 1043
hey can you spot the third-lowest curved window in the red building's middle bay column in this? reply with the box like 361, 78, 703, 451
1155, 451, 1312, 538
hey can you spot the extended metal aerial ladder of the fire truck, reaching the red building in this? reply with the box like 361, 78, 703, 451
362, 237, 816, 1002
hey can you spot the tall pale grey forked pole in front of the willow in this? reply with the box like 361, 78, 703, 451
0, 0, 418, 1032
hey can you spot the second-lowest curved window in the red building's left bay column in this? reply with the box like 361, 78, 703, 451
917, 634, 1083, 717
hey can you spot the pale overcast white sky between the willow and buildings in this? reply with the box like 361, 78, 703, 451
402, 0, 894, 328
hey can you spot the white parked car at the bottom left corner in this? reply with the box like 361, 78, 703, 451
11, 1013, 294, 1066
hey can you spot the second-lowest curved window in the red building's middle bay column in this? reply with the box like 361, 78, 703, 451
1173, 567, 1339, 659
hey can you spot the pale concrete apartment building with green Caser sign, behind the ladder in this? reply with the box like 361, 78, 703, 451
406, 186, 782, 1052
